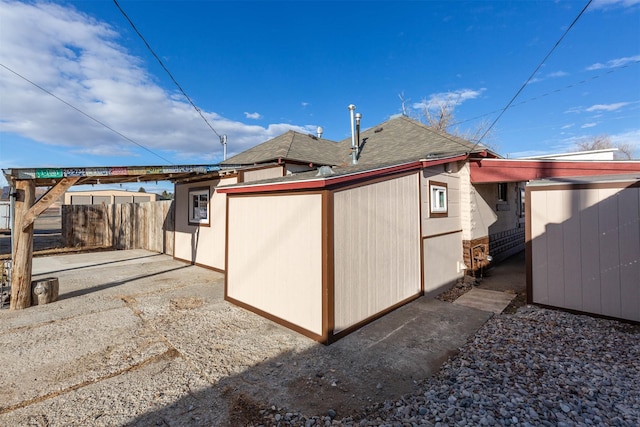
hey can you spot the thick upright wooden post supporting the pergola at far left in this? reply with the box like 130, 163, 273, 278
9, 180, 36, 310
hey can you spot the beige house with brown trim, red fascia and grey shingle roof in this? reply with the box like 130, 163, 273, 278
175, 116, 640, 343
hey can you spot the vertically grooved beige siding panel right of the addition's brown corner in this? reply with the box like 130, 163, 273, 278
334, 174, 421, 333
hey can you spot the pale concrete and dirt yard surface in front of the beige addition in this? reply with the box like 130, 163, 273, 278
0, 250, 491, 426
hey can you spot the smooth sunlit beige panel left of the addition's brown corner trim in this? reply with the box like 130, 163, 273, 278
227, 194, 322, 335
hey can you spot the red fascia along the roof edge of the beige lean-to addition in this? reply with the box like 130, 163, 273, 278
216, 155, 467, 194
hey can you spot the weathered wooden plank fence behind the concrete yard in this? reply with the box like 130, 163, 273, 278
62, 200, 175, 255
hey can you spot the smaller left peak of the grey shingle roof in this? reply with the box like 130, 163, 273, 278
222, 130, 340, 165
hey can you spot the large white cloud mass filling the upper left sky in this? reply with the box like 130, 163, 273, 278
0, 0, 315, 164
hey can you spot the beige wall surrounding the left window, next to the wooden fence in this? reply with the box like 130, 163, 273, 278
174, 177, 237, 270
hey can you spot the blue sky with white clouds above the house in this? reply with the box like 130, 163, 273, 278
0, 0, 640, 191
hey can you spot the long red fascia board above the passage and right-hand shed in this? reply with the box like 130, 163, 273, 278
470, 159, 640, 184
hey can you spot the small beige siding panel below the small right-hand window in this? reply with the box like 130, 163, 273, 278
423, 232, 464, 293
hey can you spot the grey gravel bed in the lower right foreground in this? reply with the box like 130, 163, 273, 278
262, 306, 640, 426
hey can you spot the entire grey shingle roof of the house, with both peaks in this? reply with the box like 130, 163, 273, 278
222, 116, 485, 171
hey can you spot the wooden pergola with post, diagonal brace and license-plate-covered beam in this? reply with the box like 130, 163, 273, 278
3, 165, 224, 310
